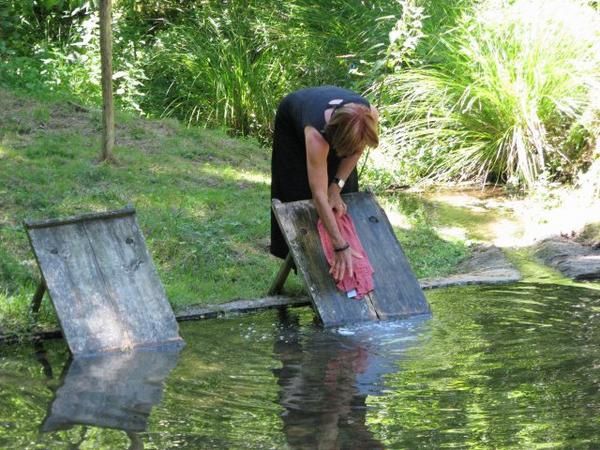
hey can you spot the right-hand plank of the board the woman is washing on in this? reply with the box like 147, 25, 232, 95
344, 192, 430, 319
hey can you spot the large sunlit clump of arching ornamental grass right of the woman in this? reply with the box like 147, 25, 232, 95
373, 0, 600, 186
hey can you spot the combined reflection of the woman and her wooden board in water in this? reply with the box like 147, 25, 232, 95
273, 313, 424, 449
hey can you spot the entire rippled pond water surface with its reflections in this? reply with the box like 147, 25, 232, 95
0, 280, 600, 449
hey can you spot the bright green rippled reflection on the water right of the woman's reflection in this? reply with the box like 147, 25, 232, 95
367, 283, 600, 450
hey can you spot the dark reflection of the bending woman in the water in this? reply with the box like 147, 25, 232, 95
273, 316, 383, 450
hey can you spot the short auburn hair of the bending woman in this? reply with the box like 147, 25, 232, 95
325, 103, 379, 157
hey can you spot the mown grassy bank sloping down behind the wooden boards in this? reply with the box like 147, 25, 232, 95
0, 89, 466, 331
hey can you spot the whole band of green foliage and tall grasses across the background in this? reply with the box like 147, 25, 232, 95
5, 0, 600, 188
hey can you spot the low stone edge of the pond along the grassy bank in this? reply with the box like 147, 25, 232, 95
0, 246, 521, 344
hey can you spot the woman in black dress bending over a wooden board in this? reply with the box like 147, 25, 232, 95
271, 86, 379, 281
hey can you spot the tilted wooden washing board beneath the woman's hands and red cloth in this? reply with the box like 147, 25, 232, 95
273, 192, 430, 326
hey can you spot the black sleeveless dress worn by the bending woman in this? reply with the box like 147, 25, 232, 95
271, 86, 369, 258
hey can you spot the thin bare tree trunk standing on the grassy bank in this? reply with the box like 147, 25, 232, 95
100, 0, 115, 161
